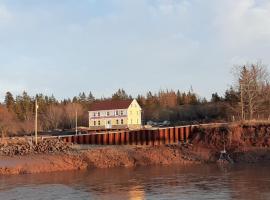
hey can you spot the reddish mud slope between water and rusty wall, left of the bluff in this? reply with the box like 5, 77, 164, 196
0, 146, 199, 175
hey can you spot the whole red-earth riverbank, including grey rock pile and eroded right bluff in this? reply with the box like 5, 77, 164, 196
0, 124, 270, 175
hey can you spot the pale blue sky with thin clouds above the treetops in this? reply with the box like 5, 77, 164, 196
0, 0, 270, 101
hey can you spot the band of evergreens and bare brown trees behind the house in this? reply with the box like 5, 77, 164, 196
0, 63, 270, 135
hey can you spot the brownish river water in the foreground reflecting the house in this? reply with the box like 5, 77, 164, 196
0, 165, 270, 200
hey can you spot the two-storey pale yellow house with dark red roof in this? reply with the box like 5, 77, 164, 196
89, 99, 142, 130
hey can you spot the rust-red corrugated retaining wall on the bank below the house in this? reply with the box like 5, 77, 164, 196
60, 124, 227, 145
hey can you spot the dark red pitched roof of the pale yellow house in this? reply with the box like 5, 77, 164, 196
90, 99, 133, 111
